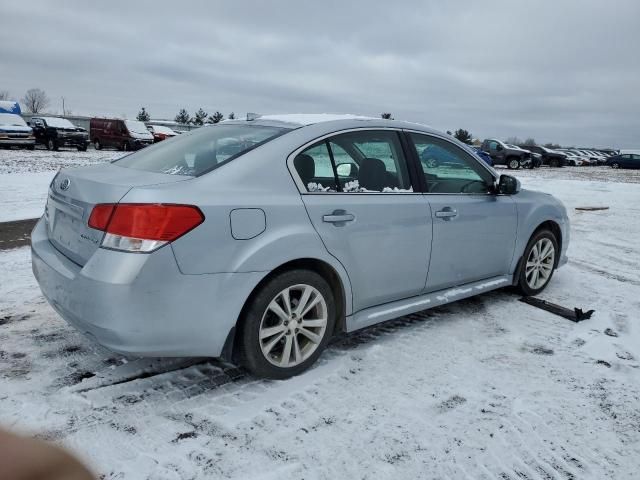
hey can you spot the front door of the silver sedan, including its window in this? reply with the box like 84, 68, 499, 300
408, 133, 517, 292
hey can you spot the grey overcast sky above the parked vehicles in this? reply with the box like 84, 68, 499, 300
0, 0, 640, 148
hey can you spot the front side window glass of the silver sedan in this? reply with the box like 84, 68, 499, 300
410, 133, 494, 194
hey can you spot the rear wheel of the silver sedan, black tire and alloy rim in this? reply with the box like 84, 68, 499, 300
238, 270, 336, 379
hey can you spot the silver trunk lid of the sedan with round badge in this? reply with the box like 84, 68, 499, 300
45, 164, 192, 266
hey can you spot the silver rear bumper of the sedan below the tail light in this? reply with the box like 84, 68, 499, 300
31, 219, 264, 357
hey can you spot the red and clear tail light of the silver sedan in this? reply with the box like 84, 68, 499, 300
89, 203, 204, 253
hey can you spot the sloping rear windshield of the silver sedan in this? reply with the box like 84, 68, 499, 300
115, 124, 290, 177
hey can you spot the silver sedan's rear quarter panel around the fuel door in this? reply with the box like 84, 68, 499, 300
121, 135, 351, 314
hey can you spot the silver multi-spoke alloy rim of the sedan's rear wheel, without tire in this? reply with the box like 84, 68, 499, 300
258, 284, 328, 368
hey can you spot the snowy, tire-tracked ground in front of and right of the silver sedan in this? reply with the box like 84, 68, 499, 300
0, 157, 640, 480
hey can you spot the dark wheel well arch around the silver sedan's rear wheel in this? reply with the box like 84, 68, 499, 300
222, 258, 346, 361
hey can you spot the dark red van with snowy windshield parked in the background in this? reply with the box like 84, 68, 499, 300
89, 118, 153, 150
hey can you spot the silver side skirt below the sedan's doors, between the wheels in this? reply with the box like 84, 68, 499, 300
346, 275, 513, 332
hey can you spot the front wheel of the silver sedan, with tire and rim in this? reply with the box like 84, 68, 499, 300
518, 229, 560, 297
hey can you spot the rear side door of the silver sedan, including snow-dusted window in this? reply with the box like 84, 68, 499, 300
290, 130, 431, 311
